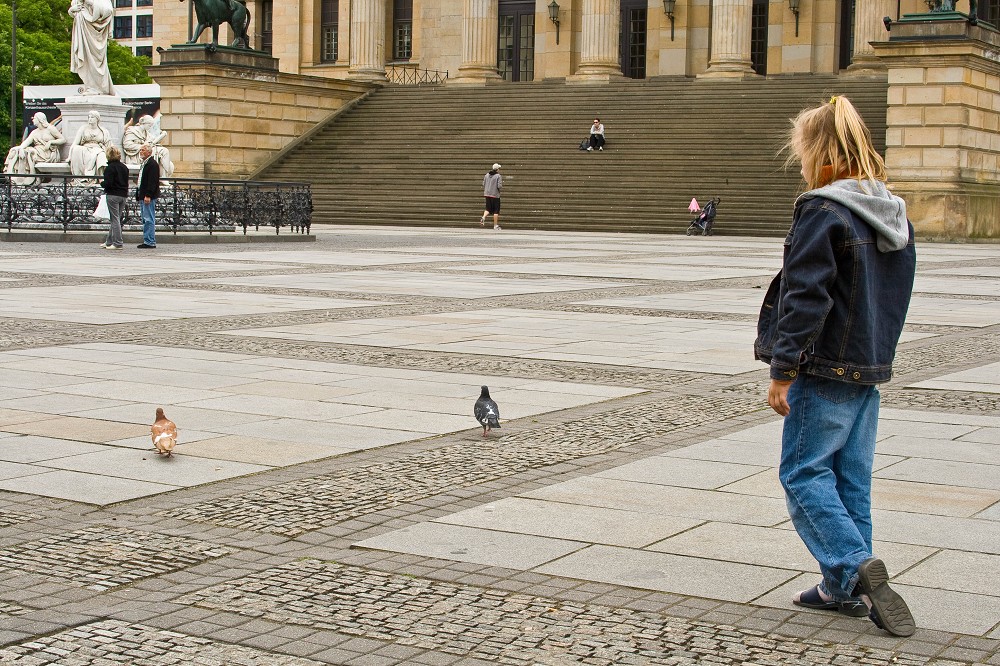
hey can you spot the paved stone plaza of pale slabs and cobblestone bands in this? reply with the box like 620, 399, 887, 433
0, 226, 1000, 666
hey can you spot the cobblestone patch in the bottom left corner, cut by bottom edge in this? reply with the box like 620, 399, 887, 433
0, 620, 320, 666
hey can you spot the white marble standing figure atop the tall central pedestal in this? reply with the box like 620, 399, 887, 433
69, 0, 115, 95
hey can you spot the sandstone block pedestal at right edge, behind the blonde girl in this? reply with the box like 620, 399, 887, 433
872, 12, 1000, 239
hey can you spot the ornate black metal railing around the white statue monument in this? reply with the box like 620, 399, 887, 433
0, 174, 313, 234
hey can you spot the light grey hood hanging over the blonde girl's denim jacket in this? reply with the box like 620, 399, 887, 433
795, 178, 910, 252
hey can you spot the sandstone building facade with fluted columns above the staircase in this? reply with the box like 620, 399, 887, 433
148, 0, 1000, 82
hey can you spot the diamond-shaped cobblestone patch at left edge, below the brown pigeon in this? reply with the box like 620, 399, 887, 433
0, 525, 232, 588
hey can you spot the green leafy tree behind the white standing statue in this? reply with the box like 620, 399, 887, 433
0, 0, 151, 157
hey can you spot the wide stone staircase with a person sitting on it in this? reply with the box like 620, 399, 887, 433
254, 75, 887, 235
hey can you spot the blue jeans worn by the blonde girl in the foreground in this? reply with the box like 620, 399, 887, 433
778, 375, 879, 601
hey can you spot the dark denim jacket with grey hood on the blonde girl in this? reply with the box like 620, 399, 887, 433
754, 179, 916, 384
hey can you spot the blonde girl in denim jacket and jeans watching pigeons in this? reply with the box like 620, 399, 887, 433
754, 96, 916, 636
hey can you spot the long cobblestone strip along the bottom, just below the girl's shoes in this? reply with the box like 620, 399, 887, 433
182, 560, 928, 666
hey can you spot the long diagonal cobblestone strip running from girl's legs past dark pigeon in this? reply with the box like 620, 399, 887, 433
160, 396, 765, 537
